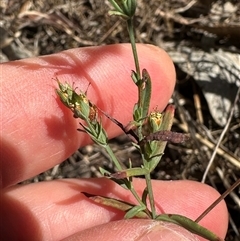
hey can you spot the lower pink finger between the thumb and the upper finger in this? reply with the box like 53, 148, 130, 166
2, 178, 227, 240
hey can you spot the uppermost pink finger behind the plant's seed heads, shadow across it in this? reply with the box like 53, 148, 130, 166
0, 44, 175, 186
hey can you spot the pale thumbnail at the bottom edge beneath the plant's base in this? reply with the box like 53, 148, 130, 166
135, 222, 199, 241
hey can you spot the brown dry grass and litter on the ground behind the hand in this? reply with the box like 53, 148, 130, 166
0, 0, 240, 241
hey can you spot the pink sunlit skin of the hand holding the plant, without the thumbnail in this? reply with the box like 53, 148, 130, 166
0, 45, 227, 240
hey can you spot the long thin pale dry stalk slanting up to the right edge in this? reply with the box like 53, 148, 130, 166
202, 86, 240, 183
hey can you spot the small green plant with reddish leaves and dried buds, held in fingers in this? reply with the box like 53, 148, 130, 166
56, 0, 236, 241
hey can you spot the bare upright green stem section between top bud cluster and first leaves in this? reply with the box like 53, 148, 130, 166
127, 18, 141, 79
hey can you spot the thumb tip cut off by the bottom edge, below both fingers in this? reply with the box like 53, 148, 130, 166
64, 219, 199, 241
